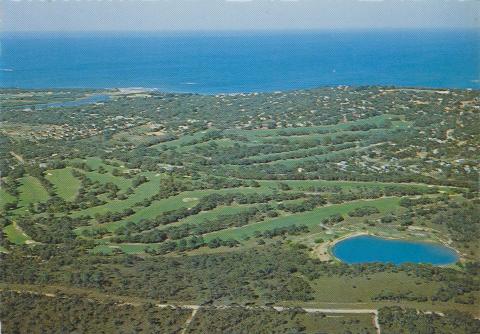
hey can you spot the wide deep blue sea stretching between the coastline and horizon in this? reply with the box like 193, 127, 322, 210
0, 30, 480, 93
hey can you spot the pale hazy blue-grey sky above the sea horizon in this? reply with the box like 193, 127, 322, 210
0, 0, 480, 31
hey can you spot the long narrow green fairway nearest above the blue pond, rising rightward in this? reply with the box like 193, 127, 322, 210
204, 197, 400, 241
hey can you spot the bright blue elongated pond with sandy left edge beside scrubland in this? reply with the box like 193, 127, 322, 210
332, 235, 458, 265
